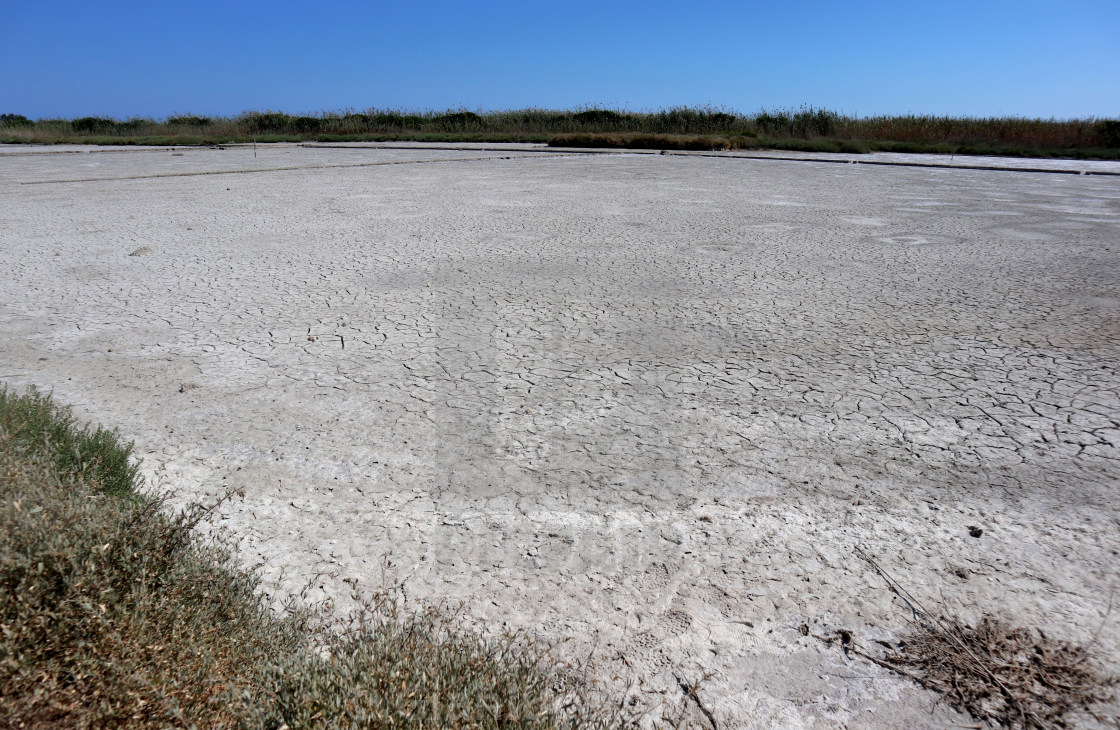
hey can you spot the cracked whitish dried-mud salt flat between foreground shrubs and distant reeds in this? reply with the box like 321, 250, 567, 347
0, 146, 1120, 728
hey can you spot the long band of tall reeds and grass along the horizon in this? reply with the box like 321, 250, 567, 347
0, 106, 1120, 149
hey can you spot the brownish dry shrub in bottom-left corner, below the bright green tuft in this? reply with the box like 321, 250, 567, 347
0, 445, 280, 728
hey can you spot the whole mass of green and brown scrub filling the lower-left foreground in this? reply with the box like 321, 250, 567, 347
0, 389, 624, 730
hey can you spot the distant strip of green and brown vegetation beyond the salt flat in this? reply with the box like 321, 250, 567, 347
0, 106, 1120, 159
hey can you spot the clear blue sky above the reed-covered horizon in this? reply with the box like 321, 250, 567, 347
0, 0, 1120, 119
